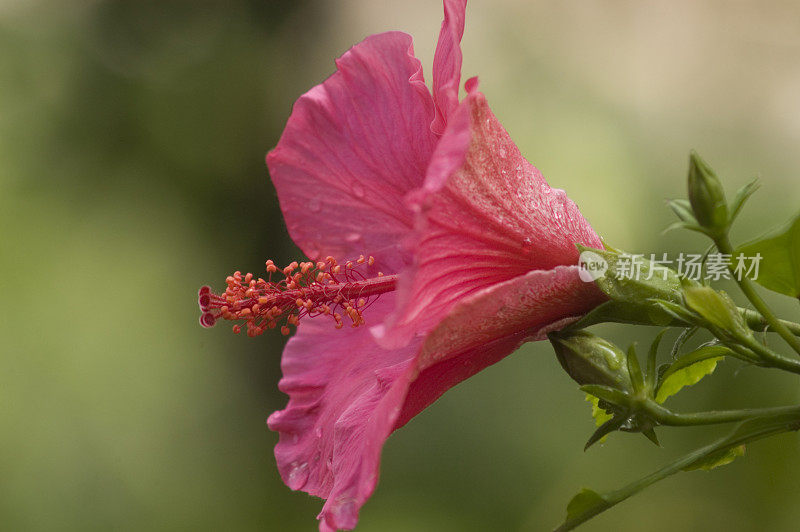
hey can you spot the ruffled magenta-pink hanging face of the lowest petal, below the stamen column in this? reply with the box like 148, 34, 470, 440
268, 294, 419, 531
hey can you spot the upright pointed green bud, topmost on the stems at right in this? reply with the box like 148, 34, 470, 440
689, 151, 728, 232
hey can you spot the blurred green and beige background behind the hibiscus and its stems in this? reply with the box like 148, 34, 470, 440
0, 0, 800, 532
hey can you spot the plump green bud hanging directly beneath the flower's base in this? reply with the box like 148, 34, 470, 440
548, 330, 631, 390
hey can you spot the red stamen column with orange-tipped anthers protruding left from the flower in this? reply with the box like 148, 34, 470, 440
197, 255, 397, 336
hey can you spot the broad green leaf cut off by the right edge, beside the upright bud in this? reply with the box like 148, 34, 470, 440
733, 213, 800, 298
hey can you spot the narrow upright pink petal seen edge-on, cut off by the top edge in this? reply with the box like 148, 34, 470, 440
431, 0, 467, 135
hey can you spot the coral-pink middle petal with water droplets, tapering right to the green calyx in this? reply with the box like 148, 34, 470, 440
380, 88, 601, 346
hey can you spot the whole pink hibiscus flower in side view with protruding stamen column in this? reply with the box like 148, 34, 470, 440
200, 0, 604, 531
